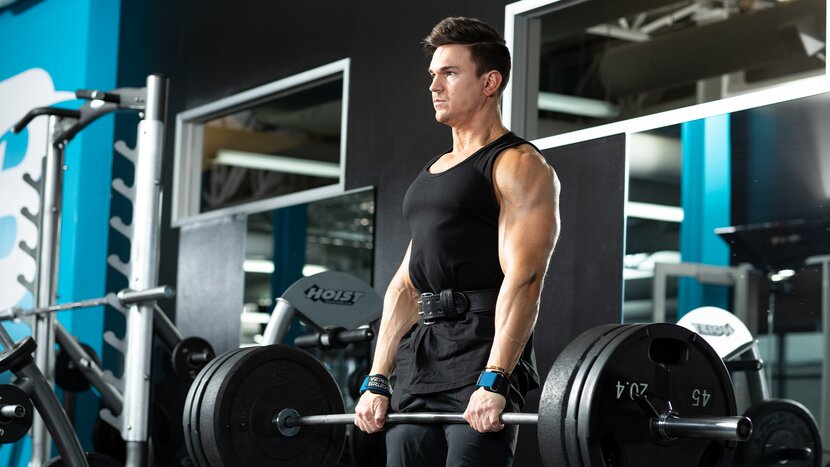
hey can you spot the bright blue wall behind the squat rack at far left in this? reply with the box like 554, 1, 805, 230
0, 0, 122, 460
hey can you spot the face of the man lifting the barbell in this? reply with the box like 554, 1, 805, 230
429, 44, 487, 126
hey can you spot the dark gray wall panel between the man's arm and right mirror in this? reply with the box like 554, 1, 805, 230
516, 135, 625, 466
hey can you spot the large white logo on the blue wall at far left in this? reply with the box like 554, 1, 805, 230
0, 68, 75, 310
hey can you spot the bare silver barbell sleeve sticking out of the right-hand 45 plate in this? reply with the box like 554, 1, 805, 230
652, 412, 752, 441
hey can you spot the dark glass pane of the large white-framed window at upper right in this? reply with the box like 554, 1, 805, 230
514, 0, 826, 138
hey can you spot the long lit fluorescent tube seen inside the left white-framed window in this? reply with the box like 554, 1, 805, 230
218, 149, 340, 178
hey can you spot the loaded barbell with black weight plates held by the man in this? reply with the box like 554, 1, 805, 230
183, 324, 752, 467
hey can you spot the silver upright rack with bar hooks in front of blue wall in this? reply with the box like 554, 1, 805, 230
3, 75, 212, 467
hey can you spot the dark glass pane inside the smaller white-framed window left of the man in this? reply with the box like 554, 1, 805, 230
200, 73, 343, 212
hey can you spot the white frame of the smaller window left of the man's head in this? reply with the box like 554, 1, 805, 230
171, 58, 351, 227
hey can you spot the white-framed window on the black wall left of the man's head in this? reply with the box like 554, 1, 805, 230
174, 60, 348, 224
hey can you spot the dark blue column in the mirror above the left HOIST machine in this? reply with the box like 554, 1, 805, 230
271, 204, 308, 343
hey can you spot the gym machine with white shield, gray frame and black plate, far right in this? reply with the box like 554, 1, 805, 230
653, 263, 824, 467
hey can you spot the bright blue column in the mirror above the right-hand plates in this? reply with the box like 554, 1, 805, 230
677, 114, 731, 318
